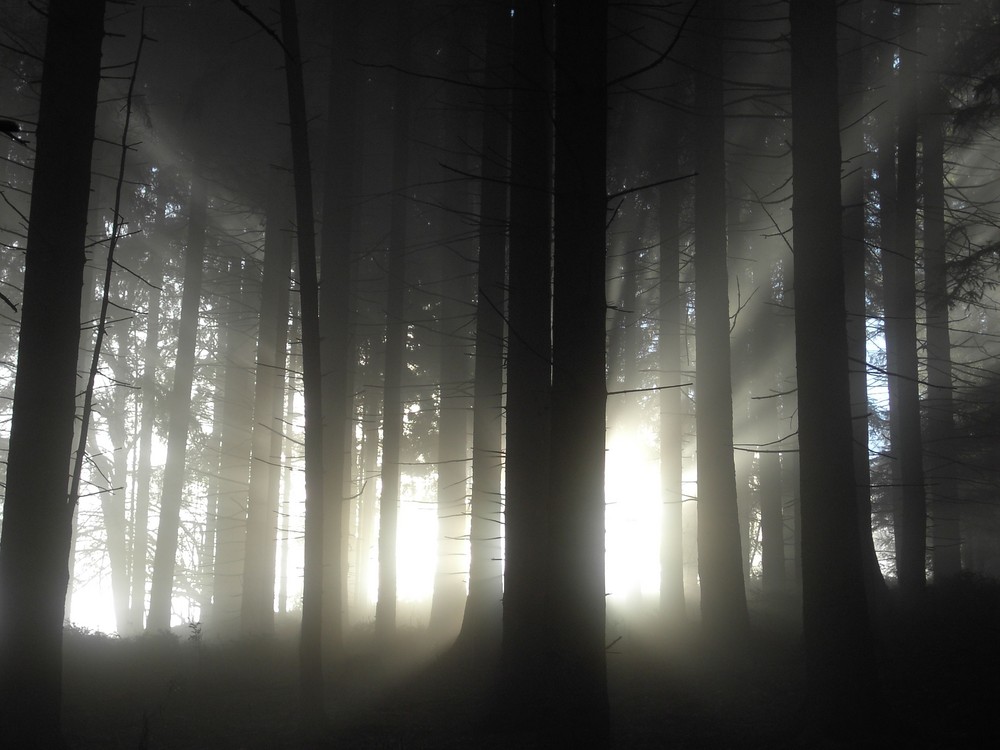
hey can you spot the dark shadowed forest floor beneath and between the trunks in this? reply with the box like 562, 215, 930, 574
64, 579, 1000, 750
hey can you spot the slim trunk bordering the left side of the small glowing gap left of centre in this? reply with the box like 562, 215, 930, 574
375, 2, 412, 644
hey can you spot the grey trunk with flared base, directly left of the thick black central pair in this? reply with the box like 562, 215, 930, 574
462, 3, 510, 650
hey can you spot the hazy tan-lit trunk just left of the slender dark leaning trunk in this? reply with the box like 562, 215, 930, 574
241, 173, 292, 636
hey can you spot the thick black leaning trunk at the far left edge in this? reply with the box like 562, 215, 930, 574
0, 0, 104, 748
